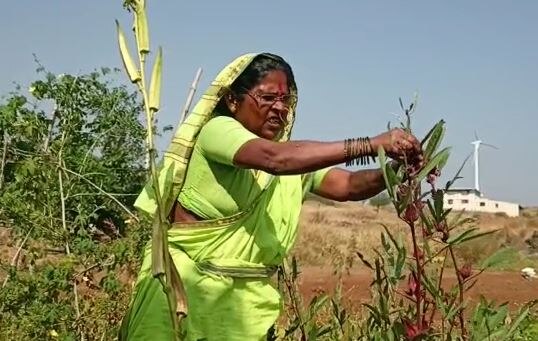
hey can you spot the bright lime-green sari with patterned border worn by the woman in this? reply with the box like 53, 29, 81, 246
120, 54, 325, 341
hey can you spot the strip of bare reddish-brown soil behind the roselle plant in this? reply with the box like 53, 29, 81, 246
299, 267, 538, 308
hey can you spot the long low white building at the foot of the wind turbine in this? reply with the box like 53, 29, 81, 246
443, 189, 519, 217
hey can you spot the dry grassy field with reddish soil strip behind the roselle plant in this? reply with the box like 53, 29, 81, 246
294, 200, 538, 307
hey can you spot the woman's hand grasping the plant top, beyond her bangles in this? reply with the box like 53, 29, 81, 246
371, 128, 422, 166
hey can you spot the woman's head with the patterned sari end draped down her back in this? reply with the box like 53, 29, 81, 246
135, 53, 297, 215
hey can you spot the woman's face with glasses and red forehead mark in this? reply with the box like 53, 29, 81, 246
231, 70, 295, 140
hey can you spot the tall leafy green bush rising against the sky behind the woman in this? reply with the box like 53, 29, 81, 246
0, 69, 145, 240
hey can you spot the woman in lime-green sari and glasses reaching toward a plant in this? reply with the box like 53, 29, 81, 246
121, 53, 421, 341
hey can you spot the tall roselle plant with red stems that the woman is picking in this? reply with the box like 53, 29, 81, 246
358, 100, 533, 340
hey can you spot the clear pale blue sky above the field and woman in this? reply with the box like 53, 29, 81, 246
0, 0, 538, 205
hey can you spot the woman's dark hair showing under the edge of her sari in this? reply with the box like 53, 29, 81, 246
216, 53, 297, 116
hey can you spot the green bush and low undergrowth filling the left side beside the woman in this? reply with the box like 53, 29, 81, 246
0, 67, 149, 340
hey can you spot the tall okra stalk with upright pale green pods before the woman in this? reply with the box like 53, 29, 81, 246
116, 0, 180, 335
